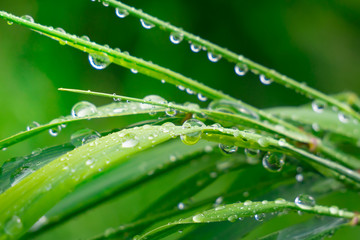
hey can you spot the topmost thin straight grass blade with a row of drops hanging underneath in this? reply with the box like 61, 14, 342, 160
102, 0, 360, 120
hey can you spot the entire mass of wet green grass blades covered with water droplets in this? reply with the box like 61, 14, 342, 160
0, 0, 360, 240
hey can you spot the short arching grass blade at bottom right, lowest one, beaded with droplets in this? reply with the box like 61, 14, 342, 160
137, 200, 357, 240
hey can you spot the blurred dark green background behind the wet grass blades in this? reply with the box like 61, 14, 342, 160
0, 0, 360, 239
